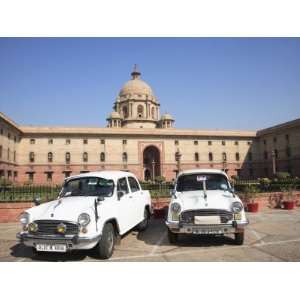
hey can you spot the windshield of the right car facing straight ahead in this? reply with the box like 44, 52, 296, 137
176, 173, 229, 192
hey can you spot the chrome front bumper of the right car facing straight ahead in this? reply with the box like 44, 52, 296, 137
166, 220, 249, 234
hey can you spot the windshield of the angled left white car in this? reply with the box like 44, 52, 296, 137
60, 177, 114, 197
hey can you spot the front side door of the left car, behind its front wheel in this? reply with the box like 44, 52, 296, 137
117, 177, 136, 234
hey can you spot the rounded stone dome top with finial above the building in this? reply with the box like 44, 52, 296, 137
119, 66, 155, 98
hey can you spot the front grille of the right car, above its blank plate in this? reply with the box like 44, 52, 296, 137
180, 209, 233, 223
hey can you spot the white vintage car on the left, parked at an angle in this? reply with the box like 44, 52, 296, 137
17, 171, 151, 259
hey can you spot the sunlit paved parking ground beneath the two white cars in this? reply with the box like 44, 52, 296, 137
0, 209, 300, 261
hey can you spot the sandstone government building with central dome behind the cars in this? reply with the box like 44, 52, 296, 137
0, 67, 300, 184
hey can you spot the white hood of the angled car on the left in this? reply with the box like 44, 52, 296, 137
27, 197, 95, 222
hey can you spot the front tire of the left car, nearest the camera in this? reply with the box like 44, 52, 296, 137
96, 223, 116, 259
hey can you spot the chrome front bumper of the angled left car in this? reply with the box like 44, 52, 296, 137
17, 232, 101, 251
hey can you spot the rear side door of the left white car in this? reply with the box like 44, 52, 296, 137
128, 176, 145, 224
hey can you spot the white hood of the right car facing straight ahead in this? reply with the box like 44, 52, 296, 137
177, 190, 240, 211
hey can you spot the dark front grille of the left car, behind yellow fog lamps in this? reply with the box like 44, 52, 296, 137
35, 220, 79, 235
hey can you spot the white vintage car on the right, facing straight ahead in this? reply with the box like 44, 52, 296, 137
166, 169, 248, 245
